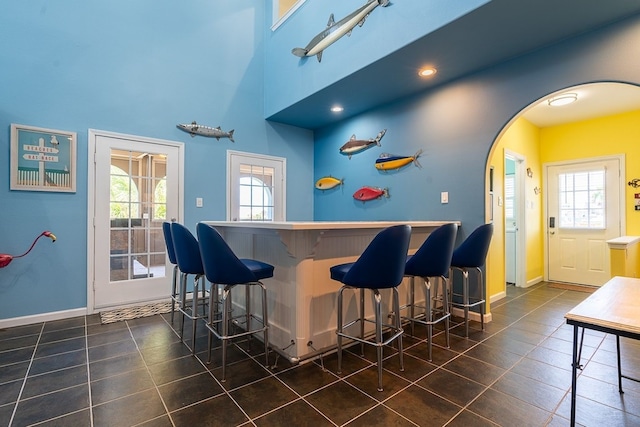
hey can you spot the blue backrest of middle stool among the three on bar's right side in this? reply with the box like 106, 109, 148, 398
405, 224, 458, 277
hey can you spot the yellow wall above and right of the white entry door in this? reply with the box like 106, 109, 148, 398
540, 110, 640, 236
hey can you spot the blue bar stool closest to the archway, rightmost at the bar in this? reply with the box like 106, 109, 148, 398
450, 224, 493, 337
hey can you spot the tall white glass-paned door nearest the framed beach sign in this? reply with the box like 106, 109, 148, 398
90, 133, 182, 308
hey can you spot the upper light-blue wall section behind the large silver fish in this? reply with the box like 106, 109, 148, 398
265, 0, 489, 117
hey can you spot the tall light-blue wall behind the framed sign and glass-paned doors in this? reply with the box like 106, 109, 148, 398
0, 0, 313, 319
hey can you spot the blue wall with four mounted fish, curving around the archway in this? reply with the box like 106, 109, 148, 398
314, 12, 640, 238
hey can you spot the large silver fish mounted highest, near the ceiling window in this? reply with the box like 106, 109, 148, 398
291, 0, 389, 62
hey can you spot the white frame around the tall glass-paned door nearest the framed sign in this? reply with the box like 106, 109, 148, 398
87, 129, 184, 314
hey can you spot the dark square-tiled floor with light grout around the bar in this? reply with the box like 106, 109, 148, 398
0, 283, 640, 427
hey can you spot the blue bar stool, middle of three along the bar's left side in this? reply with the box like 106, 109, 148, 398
171, 222, 206, 354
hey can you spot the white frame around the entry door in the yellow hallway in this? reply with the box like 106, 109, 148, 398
542, 154, 627, 281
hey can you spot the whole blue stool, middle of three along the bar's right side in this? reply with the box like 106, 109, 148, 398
403, 224, 458, 361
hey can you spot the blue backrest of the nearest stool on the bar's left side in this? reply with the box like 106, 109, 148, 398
196, 222, 257, 285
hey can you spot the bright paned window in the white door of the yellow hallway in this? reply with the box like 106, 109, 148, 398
558, 170, 606, 229
